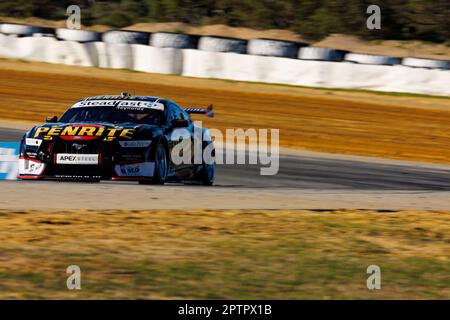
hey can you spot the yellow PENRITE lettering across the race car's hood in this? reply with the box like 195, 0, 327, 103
33, 125, 135, 141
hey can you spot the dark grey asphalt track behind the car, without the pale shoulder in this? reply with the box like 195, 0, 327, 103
0, 128, 450, 191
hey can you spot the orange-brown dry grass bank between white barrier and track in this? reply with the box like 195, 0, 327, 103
0, 60, 450, 163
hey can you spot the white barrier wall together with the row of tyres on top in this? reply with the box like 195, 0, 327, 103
0, 24, 450, 95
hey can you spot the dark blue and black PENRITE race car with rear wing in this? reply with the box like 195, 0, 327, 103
18, 93, 216, 185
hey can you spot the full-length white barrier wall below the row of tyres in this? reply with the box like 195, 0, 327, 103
0, 34, 450, 95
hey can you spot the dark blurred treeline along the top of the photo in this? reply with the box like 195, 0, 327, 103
0, 0, 450, 42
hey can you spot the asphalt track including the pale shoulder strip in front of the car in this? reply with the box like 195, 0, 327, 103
0, 128, 450, 209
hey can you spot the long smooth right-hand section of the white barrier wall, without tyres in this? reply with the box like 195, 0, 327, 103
182, 50, 450, 95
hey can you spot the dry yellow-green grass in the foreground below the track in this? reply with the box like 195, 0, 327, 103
0, 210, 450, 299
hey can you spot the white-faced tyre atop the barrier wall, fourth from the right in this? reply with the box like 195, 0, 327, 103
247, 39, 306, 58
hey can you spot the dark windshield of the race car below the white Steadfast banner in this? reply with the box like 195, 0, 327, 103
60, 107, 163, 125
